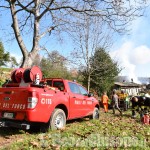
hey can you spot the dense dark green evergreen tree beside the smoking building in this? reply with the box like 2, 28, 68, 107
82, 48, 121, 96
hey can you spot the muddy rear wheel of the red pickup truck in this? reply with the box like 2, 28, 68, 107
50, 108, 66, 130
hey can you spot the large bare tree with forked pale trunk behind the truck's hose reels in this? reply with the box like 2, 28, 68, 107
0, 0, 145, 67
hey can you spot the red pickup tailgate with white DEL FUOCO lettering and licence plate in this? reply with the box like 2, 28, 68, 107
0, 87, 31, 119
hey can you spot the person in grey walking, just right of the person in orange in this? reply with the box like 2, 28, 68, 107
112, 90, 122, 115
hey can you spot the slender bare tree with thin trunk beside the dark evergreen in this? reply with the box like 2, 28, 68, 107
69, 16, 113, 91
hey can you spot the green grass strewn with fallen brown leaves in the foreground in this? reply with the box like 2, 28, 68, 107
0, 110, 150, 150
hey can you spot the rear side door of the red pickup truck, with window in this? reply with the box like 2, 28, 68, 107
68, 82, 85, 118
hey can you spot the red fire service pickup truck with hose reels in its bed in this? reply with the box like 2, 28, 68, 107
0, 66, 99, 130
